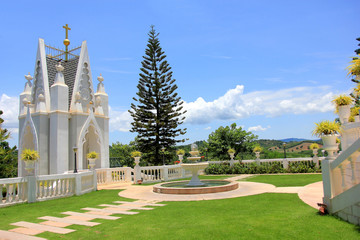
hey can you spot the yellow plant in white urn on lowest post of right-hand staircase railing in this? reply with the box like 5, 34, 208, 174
313, 120, 340, 154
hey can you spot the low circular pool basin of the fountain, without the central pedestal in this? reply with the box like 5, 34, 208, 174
153, 180, 239, 194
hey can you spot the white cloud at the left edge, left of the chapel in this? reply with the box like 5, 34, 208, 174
0, 94, 19, 128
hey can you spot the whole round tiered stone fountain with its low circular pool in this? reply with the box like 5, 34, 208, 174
153, 144, 239, 194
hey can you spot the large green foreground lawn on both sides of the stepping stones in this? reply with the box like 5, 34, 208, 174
0, 175, 360, 240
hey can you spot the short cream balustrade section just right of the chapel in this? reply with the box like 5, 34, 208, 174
96, 167, 132, 185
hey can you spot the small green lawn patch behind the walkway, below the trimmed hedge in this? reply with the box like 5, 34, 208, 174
241, 174, 322, 187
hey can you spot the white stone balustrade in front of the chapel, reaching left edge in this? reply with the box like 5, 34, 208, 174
0, 171, 97, 207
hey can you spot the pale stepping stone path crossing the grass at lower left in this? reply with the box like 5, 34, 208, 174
0, 201, 165, 240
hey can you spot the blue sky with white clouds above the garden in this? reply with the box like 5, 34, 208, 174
0, 0, 360, 144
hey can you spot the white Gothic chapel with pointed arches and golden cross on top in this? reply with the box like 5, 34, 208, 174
18, 25, 109, 177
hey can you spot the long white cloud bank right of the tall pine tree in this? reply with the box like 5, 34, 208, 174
184, 85, 334, 124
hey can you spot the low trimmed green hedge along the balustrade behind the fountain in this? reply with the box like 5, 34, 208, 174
205, 162, 321, 174
